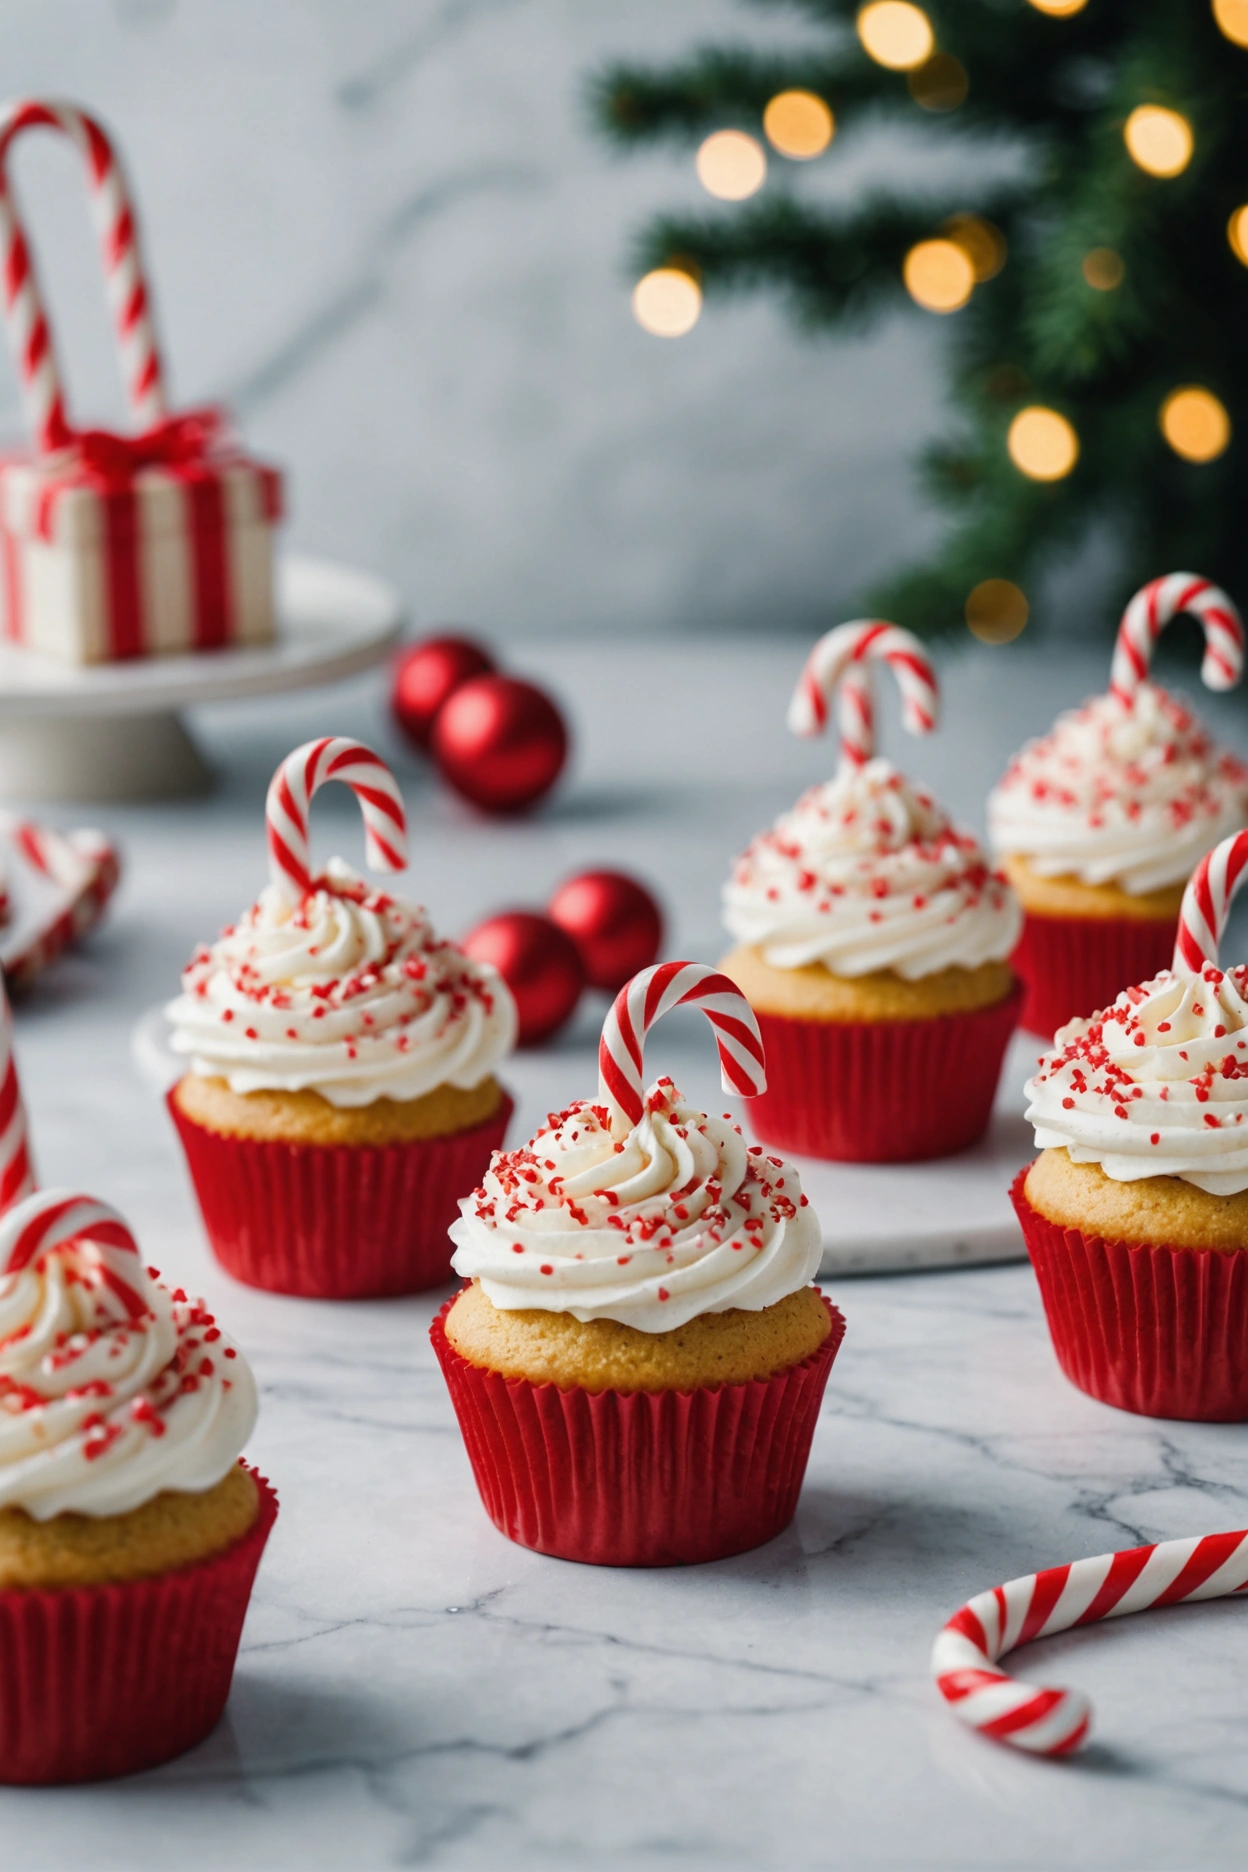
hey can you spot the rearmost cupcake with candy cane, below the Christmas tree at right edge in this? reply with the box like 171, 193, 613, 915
988, 573, 1248, 1035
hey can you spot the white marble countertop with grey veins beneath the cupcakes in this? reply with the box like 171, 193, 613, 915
0, 640, 1248, 1872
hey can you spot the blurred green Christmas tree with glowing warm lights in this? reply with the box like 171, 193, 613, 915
593, 0, 1248, 640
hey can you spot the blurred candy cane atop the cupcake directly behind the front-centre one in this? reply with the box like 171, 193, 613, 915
788, 618, 941, 771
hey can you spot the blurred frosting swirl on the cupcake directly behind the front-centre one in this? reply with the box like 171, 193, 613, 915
724, 760, 1022, 981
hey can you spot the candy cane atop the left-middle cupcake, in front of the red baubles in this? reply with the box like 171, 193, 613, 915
264, 736, 408, 897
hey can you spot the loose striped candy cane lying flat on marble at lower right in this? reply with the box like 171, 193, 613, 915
932, 1528, 1248, 1756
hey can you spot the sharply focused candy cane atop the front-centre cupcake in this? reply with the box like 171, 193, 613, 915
599, 962, 767, 1125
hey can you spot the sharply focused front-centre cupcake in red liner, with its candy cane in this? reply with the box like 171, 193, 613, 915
432, 962, 844, 1567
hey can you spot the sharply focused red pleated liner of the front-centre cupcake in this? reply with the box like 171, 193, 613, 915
428, 1295, 846, 1567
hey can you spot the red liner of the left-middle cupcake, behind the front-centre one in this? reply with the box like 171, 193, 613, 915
167, 1091, 513, 1299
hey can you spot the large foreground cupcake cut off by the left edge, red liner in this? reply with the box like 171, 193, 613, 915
0, 1191, 277, 1782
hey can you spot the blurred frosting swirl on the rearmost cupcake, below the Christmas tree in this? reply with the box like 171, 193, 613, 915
988, 683, 1248, 897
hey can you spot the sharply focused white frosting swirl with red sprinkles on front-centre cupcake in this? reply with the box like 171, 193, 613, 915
451, 1078, 821, 1333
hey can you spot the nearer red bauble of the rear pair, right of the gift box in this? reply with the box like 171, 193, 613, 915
434, 676, 567, 812
